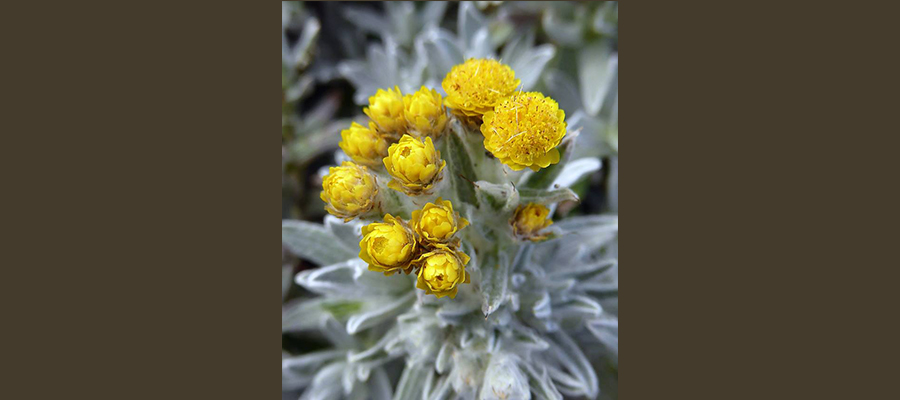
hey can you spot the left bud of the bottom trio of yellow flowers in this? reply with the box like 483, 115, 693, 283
359, 214, 416, 275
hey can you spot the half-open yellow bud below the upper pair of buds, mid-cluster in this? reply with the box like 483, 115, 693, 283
384, 135, 447, 196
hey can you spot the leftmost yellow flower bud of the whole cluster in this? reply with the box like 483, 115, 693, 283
319, 161, 378, 221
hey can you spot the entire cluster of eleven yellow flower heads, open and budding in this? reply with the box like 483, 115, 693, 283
321, 59, 566, 298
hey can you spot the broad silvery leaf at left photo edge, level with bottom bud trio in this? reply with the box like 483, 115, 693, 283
281, 220, 357, 265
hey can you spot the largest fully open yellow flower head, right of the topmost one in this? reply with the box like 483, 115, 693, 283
481, 92, 566, 171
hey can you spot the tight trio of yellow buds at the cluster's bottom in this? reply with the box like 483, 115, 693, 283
359, 197, 469, 299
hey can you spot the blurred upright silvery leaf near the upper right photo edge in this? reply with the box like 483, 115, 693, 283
578, 41, 619, 116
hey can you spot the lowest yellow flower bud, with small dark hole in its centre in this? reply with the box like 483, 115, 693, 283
415, 245, 469, 299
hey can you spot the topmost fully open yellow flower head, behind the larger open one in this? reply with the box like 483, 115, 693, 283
441, 58, 520, 117
